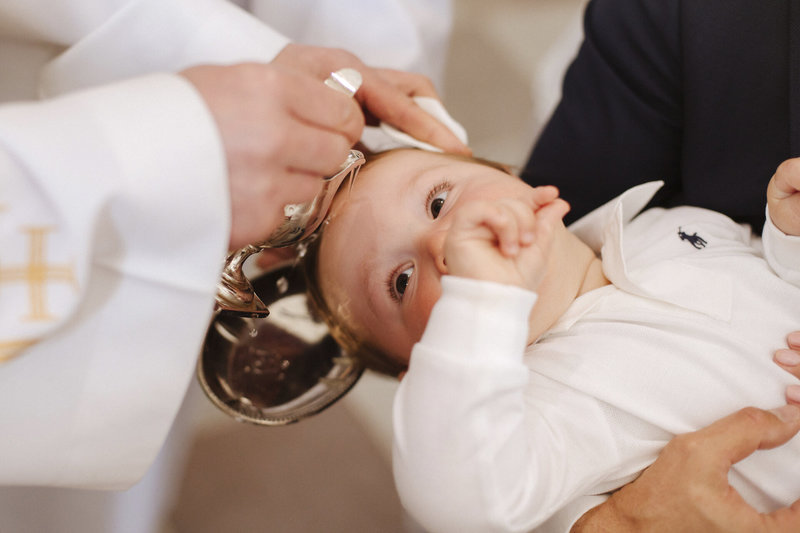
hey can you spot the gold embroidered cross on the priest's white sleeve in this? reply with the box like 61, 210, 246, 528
0, 227, 77, 320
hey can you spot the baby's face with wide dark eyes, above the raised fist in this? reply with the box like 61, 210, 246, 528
319, 150, 533, 363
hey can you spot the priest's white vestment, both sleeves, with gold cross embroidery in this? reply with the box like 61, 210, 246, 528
0, 0, 287, 488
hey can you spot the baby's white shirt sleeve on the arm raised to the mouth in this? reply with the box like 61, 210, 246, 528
394, 276, 564, 532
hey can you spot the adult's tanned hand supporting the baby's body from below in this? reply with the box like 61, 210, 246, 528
572, 405, 800, 533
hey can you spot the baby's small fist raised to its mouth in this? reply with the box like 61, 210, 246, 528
444, 187, 569, 296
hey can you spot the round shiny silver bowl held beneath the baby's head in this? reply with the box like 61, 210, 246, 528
197, 263, 364, 426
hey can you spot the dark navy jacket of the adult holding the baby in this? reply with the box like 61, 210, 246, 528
522, 0, 800, 230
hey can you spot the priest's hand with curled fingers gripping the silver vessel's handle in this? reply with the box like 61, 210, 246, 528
181, 63, 364, 249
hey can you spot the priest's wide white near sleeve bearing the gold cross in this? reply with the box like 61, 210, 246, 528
0, 74, 229, 488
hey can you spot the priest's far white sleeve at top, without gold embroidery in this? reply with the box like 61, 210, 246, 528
40, 0, 289, 96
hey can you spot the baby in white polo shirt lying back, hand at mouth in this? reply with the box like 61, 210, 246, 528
306, 150, 800, 532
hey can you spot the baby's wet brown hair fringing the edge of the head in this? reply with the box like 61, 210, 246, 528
301, 148, 513, 377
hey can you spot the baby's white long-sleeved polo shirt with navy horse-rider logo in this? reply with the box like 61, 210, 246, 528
394, 184, 800, 532
